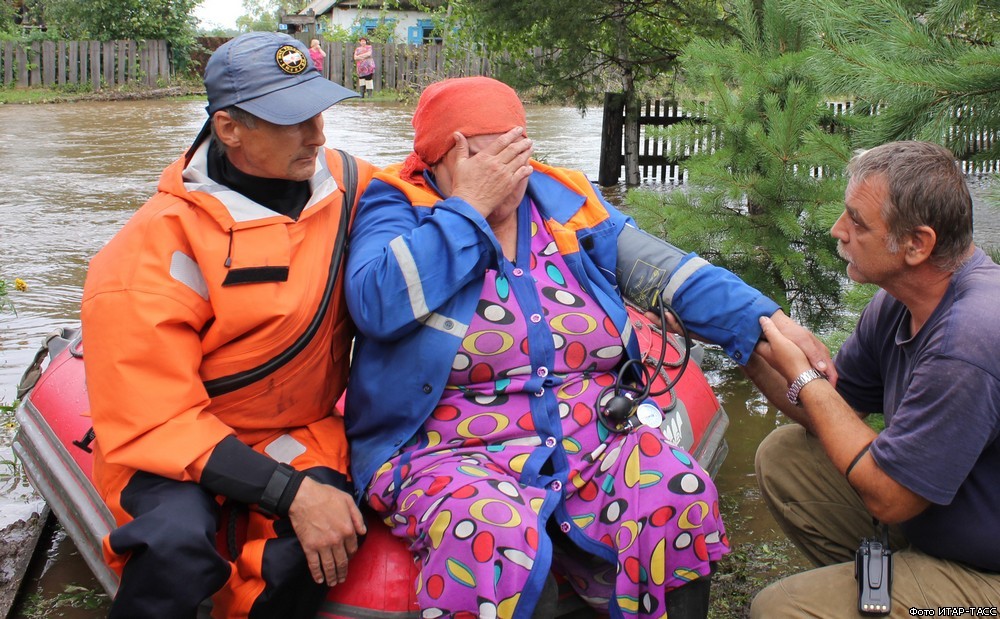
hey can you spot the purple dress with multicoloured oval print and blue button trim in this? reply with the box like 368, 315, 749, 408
368, 204, 729, 617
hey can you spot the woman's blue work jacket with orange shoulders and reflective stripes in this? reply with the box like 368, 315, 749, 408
345, 162, 779, 499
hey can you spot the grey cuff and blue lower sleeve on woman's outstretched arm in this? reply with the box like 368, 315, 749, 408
615, 226, 781, 364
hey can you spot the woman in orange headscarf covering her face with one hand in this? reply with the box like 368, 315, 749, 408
345, 77, 829, 619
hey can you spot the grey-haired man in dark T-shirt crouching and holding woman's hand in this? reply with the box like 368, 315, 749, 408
748, 141, 1000, 619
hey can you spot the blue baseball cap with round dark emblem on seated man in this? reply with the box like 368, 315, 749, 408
205, 32, 358, 125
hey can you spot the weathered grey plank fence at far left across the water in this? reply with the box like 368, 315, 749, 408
0, 40, 171, 90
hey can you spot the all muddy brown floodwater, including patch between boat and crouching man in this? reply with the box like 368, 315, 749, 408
0, 100, 1000, 618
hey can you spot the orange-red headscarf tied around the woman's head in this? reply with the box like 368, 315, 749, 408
400, 77, 527, 185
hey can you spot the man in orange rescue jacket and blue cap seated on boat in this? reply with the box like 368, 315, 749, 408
81, 32, 374, 619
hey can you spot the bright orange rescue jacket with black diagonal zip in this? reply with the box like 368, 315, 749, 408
81, 142, 375, 497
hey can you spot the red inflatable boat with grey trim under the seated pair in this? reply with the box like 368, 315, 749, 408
14, 312, 729, 619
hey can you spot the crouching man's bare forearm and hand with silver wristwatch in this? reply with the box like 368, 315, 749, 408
752, 318, 930, 524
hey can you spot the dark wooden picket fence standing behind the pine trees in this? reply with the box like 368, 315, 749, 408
598, 93, 1000, 186
